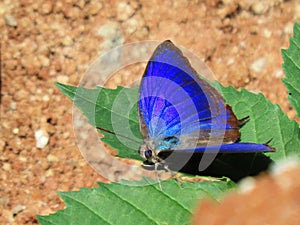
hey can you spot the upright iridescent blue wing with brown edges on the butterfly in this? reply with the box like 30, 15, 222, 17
138, 41, 240, 146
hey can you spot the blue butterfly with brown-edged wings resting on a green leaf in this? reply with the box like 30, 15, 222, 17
138, 40, 275, 175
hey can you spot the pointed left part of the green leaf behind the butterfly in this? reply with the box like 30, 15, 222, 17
55, 83, 142, 160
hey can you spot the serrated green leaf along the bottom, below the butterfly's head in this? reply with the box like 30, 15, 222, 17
38, 179, 235, 225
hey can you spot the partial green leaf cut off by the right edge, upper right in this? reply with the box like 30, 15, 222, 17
281, 23, 300, 117
